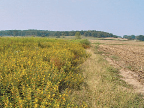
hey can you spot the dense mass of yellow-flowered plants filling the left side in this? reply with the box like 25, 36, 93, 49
0, 37, 88, 108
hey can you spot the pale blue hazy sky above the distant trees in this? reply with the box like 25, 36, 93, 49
0, 0, 144, 36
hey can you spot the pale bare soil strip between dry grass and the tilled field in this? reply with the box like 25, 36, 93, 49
91, 40, 144, 98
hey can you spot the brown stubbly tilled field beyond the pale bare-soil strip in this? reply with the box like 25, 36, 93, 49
93, 40, 144, 83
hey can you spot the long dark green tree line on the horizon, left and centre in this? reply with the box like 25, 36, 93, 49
0, 29, 118, 38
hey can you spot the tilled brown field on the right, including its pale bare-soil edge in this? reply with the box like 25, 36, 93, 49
91, 40, 144, 94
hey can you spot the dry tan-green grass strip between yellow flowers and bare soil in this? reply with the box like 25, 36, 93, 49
70, 44, 144, 108
